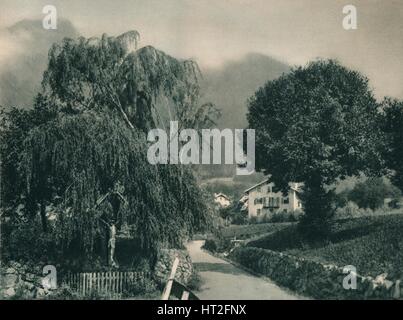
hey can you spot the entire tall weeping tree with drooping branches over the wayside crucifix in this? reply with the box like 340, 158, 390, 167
9, 32, 216, 266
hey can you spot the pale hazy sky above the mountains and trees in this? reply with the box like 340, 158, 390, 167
0, 0, 403, 98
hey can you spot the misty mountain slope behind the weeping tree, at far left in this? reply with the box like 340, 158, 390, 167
0, 19, 79, 108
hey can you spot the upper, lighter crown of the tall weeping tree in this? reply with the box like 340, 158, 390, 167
42, 31, 218, 131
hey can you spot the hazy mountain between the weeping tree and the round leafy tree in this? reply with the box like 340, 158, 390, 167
202, 53, 290, 128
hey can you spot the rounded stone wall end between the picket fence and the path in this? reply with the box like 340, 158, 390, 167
154, 249, 193, 284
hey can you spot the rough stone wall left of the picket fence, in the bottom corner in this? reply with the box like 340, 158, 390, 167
0, 262, 50, 299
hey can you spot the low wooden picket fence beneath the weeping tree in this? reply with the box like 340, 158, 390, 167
63, 271, 151, 295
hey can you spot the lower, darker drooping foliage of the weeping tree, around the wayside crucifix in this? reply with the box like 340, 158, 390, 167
21, 112, 206, 252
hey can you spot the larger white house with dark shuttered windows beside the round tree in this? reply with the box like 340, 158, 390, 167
245, 179, 302, 218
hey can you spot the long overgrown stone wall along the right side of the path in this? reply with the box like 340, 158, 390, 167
230, 246, 403, 299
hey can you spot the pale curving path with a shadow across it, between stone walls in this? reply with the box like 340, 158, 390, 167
187, 240, 300, 300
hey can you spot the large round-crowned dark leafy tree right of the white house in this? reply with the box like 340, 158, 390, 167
248, 60, 382, 238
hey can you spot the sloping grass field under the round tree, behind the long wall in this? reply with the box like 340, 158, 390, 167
249, 214, 403, 279
